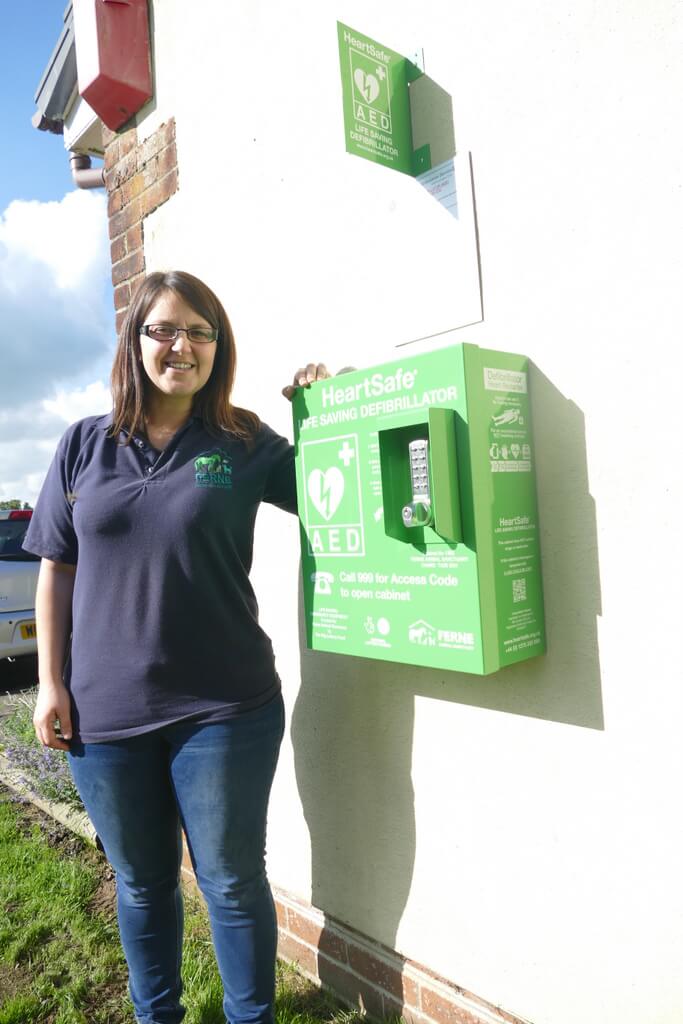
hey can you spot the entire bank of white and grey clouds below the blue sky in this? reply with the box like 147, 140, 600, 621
0, 191, 116, 503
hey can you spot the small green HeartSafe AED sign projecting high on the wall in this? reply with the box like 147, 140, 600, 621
337, 22, 422, 175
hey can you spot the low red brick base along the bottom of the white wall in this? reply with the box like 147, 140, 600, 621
182, 850, 528, 1024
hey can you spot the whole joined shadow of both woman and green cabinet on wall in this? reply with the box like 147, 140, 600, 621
292, 367, 604, 962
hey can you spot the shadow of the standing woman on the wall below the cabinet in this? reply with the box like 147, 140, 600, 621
292, 595, 415, 983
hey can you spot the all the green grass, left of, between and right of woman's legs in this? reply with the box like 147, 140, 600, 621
0, 786, 359, 1024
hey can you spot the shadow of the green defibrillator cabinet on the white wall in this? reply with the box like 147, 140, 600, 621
405, 364, 604, 730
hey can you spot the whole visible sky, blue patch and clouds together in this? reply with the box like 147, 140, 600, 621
0, 0, 115, 503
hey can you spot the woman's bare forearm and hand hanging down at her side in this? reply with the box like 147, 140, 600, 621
33, 558, 76, 751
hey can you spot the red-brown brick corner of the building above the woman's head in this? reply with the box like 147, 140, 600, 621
103, 118, 178, 334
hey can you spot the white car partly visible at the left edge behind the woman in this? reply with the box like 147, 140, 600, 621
0, 509, 40, 659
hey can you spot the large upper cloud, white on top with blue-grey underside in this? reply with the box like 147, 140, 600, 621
0, 191, 115, 409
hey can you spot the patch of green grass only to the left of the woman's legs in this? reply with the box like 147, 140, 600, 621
0, 797, 133, 1024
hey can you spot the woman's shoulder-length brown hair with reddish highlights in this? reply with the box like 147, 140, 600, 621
111, 270, 260, 443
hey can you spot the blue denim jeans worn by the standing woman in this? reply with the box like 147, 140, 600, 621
69, 696, 284, 1024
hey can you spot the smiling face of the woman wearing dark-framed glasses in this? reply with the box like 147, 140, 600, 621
140, 291, 217, 399
